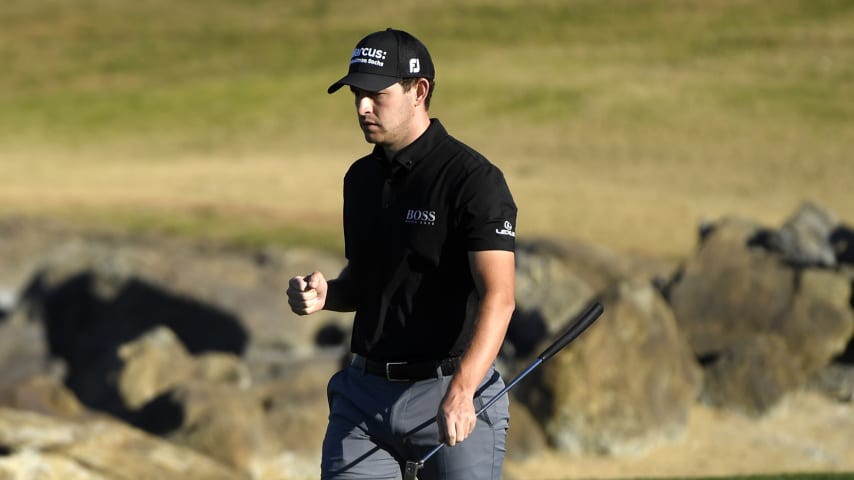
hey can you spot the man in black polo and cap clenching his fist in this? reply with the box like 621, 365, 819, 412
287, 29, 516, 480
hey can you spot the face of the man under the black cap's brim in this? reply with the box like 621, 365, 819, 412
350, 83, 420, 151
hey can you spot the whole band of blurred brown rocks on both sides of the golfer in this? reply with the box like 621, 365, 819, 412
0, 201, 854, 480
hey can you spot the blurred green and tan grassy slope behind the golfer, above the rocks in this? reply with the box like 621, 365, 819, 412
0, 0, 854, 258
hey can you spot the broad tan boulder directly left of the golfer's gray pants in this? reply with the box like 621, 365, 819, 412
126, 350, 340, 479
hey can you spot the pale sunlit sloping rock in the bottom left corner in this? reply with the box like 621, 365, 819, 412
0, 408, 245, 480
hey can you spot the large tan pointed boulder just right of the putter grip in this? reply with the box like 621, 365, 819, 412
520, 281, 702, 455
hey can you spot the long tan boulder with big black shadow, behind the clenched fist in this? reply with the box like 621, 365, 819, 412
7, 240, 349, 417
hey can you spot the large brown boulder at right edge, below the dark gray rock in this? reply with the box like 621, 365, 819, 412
668, 210, 854, 415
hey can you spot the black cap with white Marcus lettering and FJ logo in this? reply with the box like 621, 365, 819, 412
327, 28, 436, 93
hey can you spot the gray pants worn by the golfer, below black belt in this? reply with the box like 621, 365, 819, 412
321, 366, 510, 480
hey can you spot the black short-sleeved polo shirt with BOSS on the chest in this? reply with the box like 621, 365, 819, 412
344, 119, 516, 361
